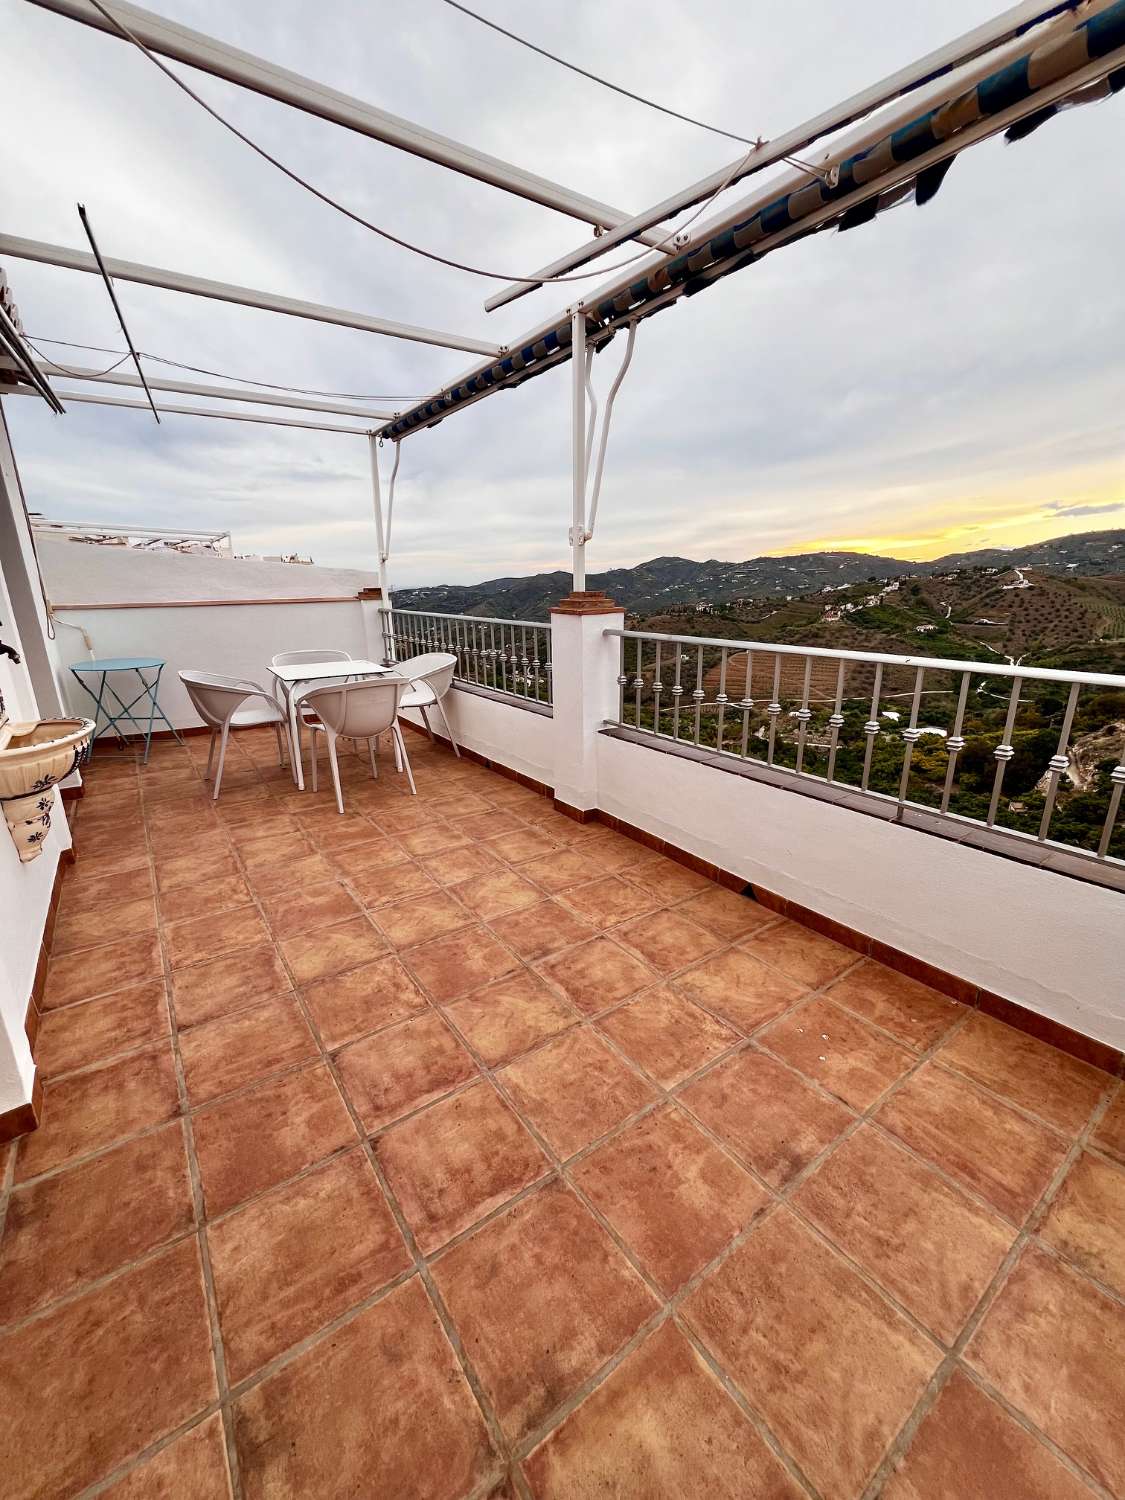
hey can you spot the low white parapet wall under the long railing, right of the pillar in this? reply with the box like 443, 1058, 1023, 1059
599, 735, 1125, 1047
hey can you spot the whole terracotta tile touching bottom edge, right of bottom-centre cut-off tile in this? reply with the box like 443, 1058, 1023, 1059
681, 1209, 941, 1500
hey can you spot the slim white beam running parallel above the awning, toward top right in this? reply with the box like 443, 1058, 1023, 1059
485, 0, 1079, 312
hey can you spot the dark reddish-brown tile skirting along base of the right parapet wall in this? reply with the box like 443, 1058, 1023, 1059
404, 720, 1125, 1076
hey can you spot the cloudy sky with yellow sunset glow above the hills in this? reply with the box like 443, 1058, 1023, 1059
0, 0, 1125, 585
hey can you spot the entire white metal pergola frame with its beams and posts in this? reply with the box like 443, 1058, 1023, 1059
0, 0, 1125, 608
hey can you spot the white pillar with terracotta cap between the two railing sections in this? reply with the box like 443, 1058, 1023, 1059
551, 593, 626, 812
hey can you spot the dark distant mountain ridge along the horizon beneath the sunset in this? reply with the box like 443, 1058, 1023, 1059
395, 530, 1125, 620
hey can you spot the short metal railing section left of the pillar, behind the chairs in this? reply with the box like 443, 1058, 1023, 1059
393, 609, 551, 705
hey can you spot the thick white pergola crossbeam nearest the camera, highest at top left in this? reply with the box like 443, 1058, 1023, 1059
30, 0, 662, 245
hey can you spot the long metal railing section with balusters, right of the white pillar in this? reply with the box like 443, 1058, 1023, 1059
606, 630, 1125, 864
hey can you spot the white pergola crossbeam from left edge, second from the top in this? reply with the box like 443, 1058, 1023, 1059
0, 234, 500, 356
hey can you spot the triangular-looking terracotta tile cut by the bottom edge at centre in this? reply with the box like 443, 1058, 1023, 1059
524, 1323, 804, 1500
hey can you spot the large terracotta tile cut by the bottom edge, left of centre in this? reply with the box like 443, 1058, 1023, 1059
234, 1277, 495, 1500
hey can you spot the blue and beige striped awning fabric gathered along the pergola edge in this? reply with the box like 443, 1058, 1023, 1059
381, 0, 1125, 441
